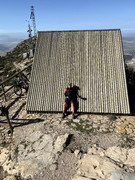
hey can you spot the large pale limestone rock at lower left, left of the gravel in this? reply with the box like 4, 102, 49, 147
0, 129, 69, 178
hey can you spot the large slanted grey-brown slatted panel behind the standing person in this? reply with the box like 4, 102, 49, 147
26, 29, 130, 114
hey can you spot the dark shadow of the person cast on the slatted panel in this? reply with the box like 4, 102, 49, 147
66, 85, 87, 117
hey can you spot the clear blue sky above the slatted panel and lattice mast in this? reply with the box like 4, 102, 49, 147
0, 0, 135, 35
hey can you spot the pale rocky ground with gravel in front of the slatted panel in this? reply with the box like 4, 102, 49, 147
0, 93, 135, 180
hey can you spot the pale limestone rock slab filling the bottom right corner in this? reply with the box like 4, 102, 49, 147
72, 147, 135, 180
